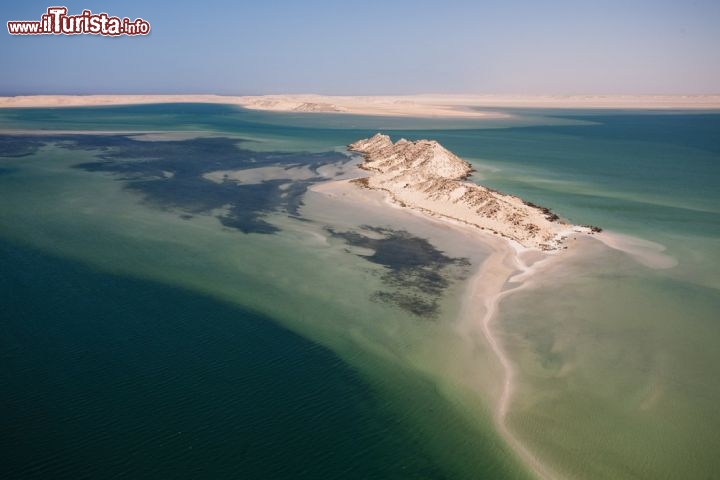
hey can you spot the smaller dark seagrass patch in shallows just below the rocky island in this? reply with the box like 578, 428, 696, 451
326, 225, 470, 318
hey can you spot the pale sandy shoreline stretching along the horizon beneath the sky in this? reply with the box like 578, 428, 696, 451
0, 94, 720, 119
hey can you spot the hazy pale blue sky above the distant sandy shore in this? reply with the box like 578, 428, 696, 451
0, 0, 720, 95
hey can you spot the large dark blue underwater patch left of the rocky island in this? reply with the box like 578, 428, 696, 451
2, 135, 347, 234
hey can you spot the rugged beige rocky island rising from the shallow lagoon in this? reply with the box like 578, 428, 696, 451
348, 133, 589, 250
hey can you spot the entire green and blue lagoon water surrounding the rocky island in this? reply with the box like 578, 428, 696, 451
0, 104, 720, 479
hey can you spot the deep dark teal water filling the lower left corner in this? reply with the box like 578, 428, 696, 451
0, 242, 443, 479
